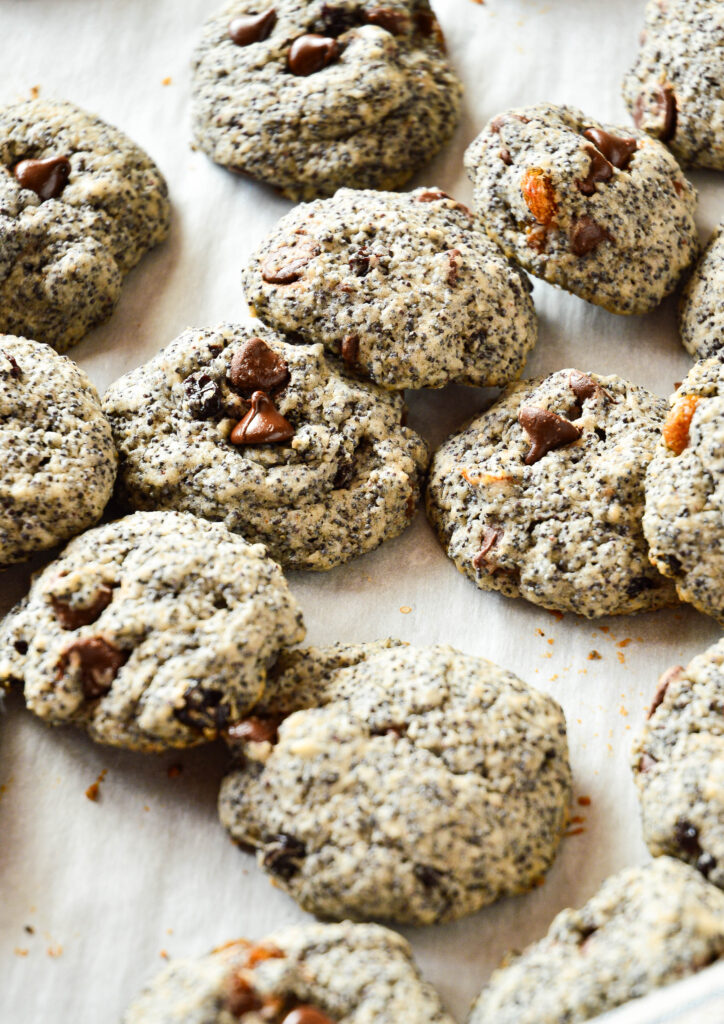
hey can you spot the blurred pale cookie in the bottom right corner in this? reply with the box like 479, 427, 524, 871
468, 857, 724, 1024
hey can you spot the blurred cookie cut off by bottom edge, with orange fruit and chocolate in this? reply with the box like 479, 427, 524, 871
123, 922, 454, 1024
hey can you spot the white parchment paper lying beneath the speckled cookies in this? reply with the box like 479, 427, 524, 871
0, 0, 724, 1024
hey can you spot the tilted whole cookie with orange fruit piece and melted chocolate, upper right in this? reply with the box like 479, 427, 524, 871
465, 104, 698, 313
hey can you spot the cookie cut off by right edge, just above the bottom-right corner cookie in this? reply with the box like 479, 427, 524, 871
632, 640, 724, 889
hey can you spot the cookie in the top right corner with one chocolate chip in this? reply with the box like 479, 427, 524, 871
624, 0, 724, 170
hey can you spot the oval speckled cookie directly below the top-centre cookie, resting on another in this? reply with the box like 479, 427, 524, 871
243, 188, 538, 388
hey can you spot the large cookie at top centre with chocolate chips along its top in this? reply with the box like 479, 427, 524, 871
191, 0, 462, 200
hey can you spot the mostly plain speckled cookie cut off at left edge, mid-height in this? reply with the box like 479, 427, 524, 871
0, 335, 117, 566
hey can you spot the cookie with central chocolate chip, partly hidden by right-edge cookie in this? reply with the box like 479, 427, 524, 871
427, 370, 676, 618
